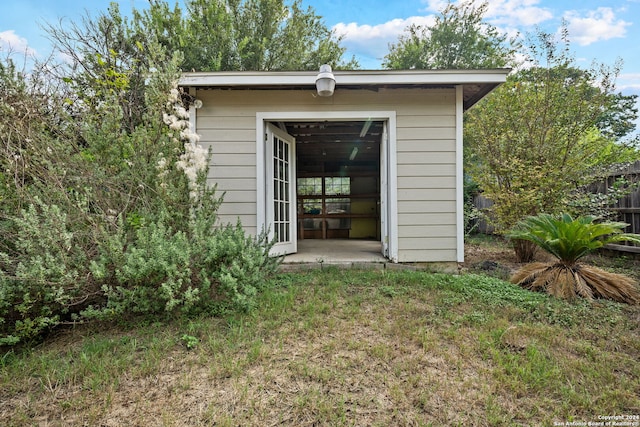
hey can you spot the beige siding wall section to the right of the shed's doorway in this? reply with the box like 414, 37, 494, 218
396, 93, 456, 262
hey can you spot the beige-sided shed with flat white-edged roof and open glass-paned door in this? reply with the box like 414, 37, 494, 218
180, 66, 509, 263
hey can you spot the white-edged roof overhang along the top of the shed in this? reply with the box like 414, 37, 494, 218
179, 68, 511, 110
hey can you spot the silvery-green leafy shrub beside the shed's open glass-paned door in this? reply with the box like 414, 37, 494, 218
83, 209, 278, 319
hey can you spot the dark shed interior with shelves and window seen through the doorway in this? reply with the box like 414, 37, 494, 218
277, 120, 384, 242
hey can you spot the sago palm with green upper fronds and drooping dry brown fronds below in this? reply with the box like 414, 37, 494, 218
508, 214, 640, 304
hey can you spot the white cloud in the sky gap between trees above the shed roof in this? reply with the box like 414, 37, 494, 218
333, 15, 434, 64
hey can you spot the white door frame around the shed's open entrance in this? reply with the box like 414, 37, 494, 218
256, 111, 398, 262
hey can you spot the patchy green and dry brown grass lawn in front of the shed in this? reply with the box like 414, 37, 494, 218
0, 262, 640, 427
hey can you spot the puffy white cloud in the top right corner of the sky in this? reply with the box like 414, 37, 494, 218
564, 7, 631, 46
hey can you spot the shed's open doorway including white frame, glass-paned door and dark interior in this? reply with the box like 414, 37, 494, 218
256, 111, 398, 262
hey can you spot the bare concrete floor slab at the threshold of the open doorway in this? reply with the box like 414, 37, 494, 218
283, 239, 388, 264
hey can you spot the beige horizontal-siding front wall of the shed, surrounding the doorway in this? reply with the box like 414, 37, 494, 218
197, 88, 456, 262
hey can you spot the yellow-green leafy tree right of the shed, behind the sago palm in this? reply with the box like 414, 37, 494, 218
465, 31, 632, 261
